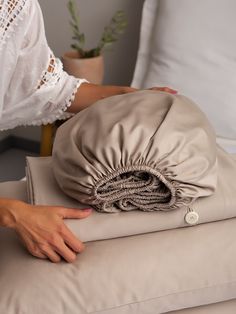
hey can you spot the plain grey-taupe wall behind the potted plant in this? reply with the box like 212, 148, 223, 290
12, 0, 143, 140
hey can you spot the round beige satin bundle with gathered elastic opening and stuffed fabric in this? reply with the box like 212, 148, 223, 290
52, 91, 217, 212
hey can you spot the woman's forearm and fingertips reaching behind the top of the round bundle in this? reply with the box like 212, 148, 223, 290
67, 83, 176, 113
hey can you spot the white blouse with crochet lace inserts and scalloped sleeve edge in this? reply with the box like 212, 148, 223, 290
0, 0, 86, 130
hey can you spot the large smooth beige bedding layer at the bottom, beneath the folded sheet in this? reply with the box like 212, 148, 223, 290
0, 182, 236, 314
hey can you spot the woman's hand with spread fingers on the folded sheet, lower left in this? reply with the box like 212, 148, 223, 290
0, 199, 92, 263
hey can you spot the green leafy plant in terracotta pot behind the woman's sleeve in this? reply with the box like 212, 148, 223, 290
62, 0, 127, 84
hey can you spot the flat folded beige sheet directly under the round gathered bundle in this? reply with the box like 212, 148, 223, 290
27, 148, 236, 241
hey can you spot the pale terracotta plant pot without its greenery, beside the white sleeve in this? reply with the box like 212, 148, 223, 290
62, 51, 104, 84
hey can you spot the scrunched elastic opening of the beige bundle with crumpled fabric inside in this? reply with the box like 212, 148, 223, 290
93, 165, 187, 212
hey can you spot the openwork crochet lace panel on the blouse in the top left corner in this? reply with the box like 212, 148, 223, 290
0, 0, 30, 50
